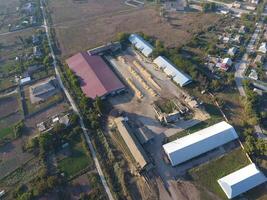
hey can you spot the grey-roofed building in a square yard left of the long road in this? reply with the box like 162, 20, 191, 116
30, 78, 58, 103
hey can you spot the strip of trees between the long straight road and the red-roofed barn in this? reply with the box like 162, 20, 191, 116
61, 62, 132, 199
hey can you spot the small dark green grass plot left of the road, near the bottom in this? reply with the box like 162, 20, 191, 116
58, 139, 92, 178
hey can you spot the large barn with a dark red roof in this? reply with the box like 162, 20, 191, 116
66, 52, 125, 99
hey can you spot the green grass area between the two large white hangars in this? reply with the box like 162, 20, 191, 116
189, 148, 250, 199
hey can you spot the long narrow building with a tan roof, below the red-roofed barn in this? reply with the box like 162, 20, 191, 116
115, 117, 148, 169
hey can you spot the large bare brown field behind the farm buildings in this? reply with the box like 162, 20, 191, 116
50, 0, 219, 56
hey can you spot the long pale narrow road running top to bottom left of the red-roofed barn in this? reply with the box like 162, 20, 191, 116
40, 0, 114, 200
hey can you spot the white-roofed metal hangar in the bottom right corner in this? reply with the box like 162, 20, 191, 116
218, 163, 267, 199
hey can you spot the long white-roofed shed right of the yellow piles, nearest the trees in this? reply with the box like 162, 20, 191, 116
153, 56, 192, 87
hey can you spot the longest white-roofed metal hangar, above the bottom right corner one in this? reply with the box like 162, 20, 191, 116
163, 121, 241, 166
